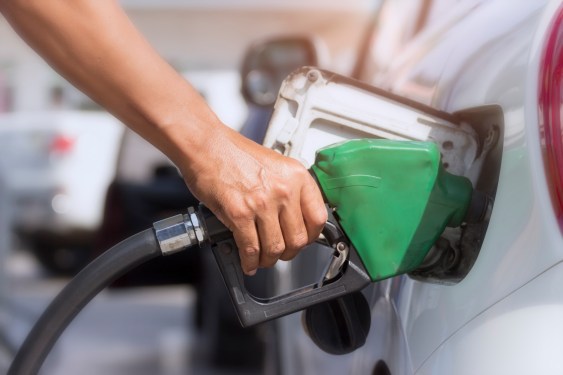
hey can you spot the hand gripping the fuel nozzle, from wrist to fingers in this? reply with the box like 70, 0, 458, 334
181, 128, 327, 275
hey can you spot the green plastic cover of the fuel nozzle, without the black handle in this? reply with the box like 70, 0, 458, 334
312, 139, 472, 281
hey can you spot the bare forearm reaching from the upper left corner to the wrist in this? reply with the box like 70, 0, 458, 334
0, 0, 221, 166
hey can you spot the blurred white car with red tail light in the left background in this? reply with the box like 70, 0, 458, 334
0, 110, 124, 272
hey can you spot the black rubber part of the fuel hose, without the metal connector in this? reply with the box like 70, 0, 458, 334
8, 229, 162, 375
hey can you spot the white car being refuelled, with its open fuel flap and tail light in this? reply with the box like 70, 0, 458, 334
265, 0, 563, 375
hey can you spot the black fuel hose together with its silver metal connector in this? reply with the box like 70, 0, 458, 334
7, 207, 212, 375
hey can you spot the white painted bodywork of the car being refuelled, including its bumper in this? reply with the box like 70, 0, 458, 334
274, 0, 563, 374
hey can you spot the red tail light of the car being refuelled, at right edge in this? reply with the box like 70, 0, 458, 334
539, 6, 563, 231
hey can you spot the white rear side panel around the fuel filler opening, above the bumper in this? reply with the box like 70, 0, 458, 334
378, 2, 563, 369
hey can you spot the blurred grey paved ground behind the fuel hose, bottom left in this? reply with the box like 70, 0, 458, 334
0, 253, 258, 375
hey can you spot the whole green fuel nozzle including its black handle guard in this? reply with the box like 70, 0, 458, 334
209, 139, 473, 326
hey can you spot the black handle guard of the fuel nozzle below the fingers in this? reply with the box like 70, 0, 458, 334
212, 232, 371, 327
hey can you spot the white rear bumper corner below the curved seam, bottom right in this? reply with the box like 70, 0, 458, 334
417, 264, 563, 375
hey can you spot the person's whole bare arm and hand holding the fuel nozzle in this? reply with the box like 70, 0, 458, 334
0, 0, 327, 275
